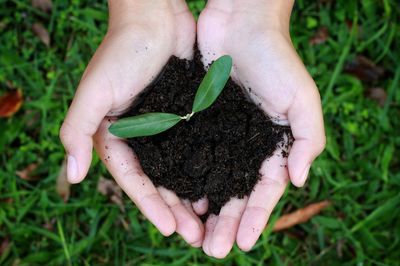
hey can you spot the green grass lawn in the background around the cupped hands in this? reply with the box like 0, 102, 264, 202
0, 0, 400, 265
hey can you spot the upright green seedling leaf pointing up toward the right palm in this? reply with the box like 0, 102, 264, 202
192, 55, 232, 113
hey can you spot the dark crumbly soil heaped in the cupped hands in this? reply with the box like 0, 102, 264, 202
123, 51, 292, 215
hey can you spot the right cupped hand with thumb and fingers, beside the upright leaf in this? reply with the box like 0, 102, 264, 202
197, 0, 325, 258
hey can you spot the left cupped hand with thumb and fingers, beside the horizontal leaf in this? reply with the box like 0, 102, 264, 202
60, 0, 204, 246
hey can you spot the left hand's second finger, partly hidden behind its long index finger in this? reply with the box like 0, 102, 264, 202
158, 187, 204, 247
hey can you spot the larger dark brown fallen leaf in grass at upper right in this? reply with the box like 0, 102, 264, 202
344, 55, 385, 83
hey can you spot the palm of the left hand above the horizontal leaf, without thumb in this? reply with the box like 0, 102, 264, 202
83, 17, 196, 116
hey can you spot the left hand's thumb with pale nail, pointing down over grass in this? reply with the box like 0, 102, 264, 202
60, 75, 112, 183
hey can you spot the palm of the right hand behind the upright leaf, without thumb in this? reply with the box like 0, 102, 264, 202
198, 9, 312, 120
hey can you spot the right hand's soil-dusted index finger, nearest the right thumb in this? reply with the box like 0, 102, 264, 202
236, 150, 289, 251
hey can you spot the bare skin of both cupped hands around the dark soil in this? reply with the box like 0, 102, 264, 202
60, 0, 325, 258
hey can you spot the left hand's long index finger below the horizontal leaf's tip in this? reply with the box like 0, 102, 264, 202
94, 120, 176, 236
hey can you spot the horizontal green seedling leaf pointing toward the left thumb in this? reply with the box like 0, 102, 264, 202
108, 113, 181, 138
